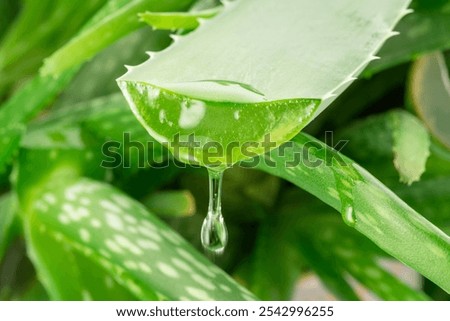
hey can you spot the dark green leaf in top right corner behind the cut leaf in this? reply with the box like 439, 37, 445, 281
363, 1, 450, 77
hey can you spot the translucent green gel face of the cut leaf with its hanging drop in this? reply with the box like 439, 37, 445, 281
118, 79, 319, 253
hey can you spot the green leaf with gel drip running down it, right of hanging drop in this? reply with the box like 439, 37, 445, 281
253, 134, 450, 292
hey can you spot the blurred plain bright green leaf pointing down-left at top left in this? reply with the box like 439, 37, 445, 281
41, 0, 193, 75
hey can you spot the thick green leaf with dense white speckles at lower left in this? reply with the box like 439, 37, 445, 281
15, 144, 255, 300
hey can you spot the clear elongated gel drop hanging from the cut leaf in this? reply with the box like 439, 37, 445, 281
201, 169, 228, 254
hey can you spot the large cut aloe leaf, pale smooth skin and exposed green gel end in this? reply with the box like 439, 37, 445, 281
118, 0, 409, 165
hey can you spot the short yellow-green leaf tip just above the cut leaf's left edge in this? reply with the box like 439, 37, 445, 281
139, 7, 221, 30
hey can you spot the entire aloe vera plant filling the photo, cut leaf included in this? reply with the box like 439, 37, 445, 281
0, 0, 450, 300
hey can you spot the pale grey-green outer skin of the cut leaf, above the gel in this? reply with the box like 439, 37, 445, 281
121, 0, 408, 109
